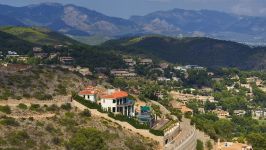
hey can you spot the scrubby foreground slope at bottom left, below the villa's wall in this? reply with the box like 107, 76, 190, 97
0, 104, 157, 150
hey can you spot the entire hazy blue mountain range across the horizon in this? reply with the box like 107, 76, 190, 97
0, 3, 266, 43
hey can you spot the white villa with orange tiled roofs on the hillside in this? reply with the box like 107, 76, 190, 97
79, 87, 135, 116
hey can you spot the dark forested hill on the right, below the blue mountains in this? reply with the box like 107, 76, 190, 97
103, 36, 266, 69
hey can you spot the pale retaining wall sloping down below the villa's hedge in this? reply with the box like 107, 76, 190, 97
72, 101, 163, 149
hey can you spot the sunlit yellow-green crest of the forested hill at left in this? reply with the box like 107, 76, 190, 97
0, 27, 78, 45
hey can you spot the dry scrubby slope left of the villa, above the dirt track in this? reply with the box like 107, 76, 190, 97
0, 66, 86, 100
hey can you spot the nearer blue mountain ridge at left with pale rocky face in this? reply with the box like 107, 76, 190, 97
0, 3, 139, 35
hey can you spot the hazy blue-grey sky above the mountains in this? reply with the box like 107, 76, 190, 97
0, 0, 266, 18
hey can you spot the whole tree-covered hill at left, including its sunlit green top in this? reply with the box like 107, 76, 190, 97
0, 27, 124, 68
